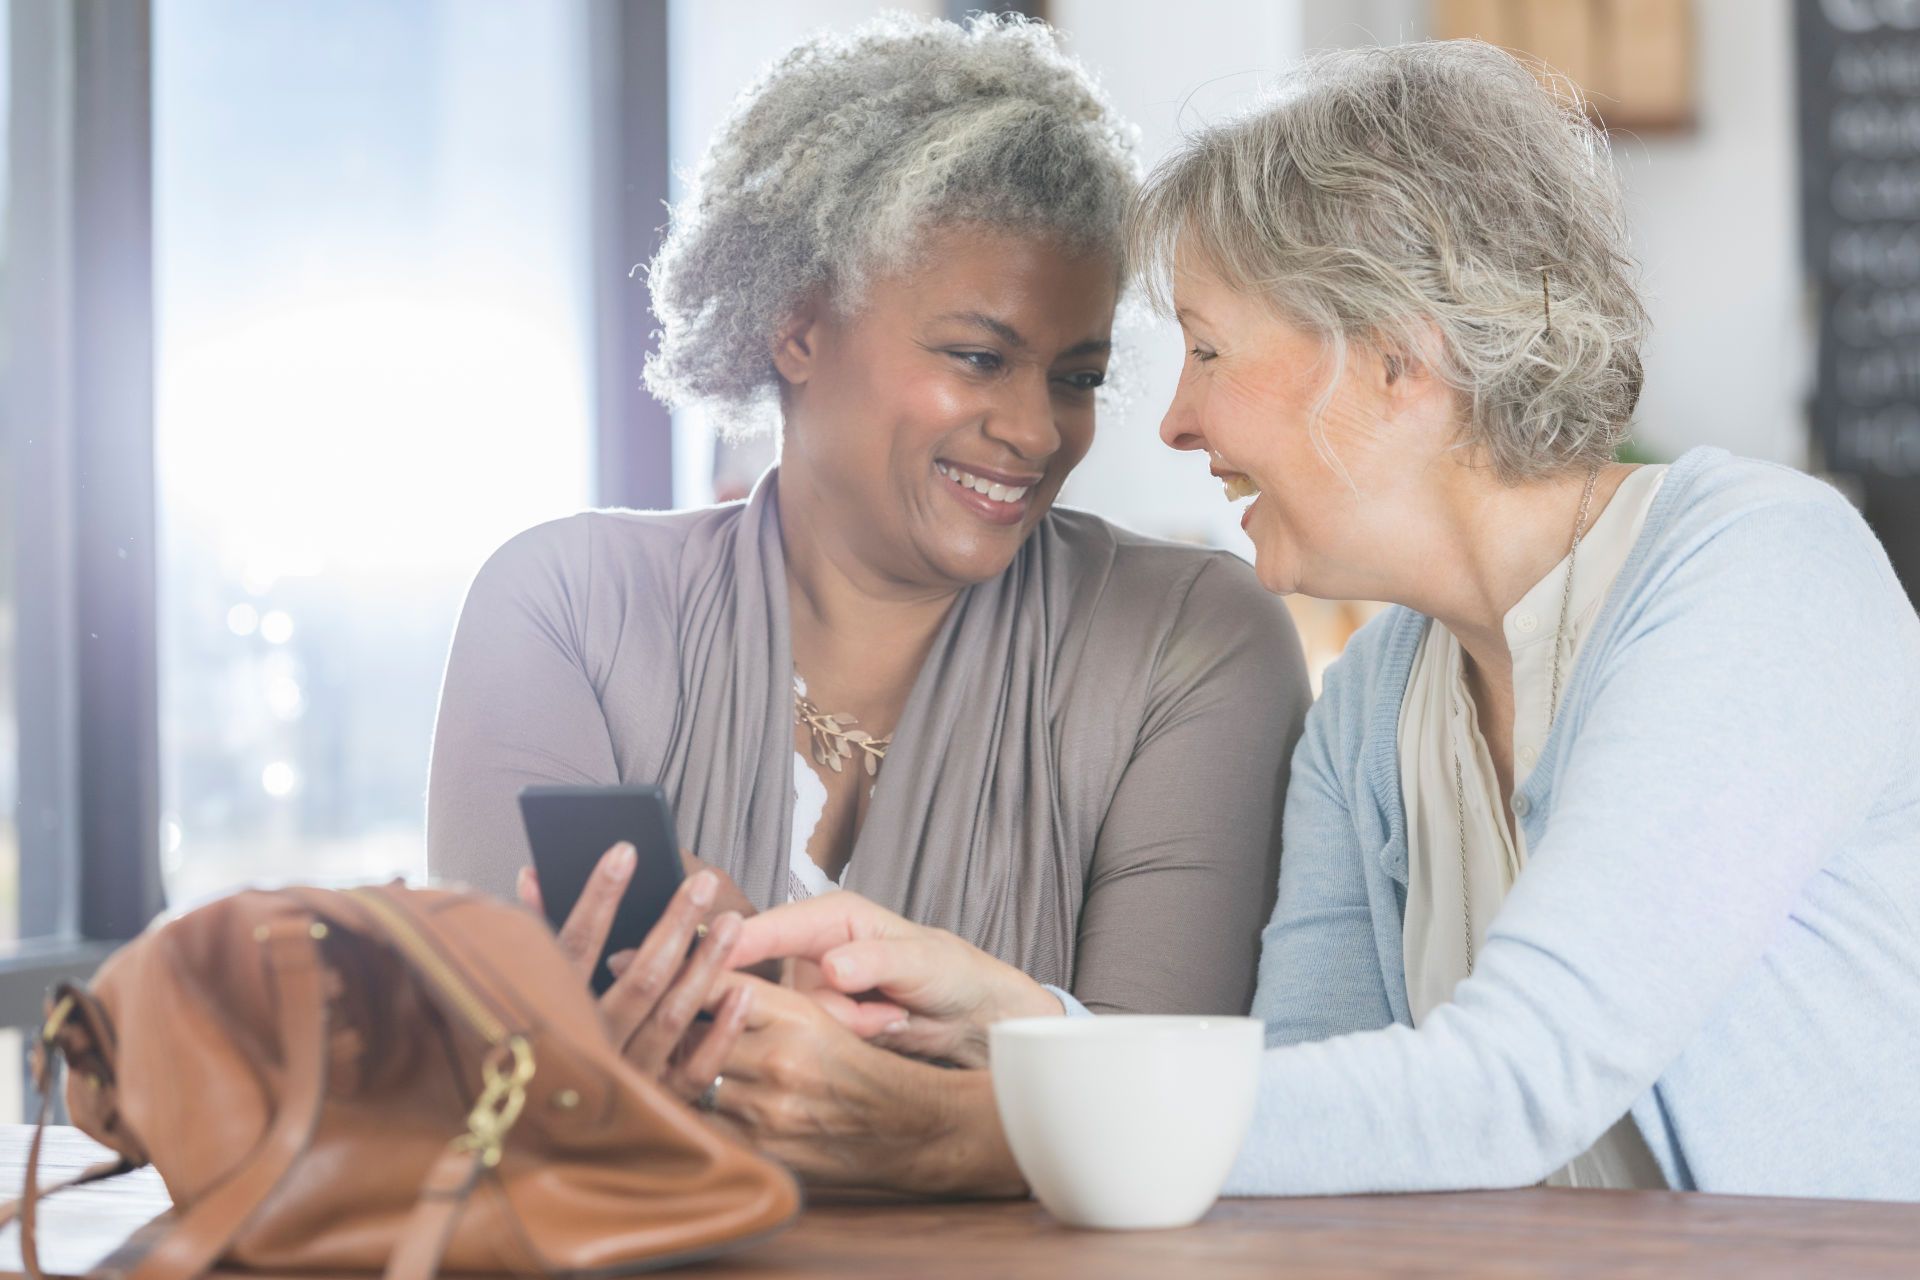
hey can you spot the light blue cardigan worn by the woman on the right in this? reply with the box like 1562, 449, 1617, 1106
1205, 449, 1920, 1199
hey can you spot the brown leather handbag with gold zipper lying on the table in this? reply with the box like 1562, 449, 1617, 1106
3, 883, 801, 1280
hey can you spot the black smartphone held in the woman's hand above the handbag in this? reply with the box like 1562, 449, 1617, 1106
520, 787, 684, 996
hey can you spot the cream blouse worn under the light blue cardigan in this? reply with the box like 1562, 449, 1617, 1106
1400, 466, 1667, 1186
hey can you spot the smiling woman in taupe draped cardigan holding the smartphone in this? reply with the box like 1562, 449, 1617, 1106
428, 17, 1309, 1190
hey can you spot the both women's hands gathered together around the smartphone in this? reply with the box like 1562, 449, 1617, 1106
518, 844, 1062, 1190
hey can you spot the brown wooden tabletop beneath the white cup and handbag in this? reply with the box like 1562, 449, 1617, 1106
0, 1126, 1920, 1280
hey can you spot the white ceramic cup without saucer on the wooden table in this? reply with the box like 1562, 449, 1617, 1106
987, 1015, 1265, 1230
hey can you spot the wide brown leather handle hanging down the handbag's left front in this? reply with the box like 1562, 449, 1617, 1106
109, 919, 326, 1280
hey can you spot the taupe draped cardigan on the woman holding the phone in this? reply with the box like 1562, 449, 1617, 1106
426, 470, 1309, 1013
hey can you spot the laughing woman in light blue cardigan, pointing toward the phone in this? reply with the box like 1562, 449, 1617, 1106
735, 42, 1920, 1197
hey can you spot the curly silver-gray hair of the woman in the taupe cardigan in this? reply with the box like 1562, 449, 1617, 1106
647, 15, 1137, 434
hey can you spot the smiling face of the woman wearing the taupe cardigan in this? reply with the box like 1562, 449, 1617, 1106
774, 226, 1119, 589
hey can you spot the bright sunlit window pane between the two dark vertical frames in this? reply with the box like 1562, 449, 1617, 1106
154, 0, 591, 902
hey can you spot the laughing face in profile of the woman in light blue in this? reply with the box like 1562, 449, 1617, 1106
1160, 257, 1436, 599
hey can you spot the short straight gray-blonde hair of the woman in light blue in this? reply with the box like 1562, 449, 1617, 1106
1131, 40, 1647, 484
